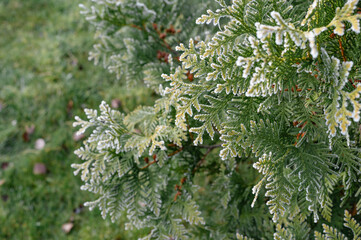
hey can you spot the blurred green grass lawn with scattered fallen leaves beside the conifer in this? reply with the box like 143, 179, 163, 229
0, 0, 152, 239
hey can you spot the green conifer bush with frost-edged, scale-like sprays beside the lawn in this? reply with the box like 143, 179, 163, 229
72, 0, 361, 239
